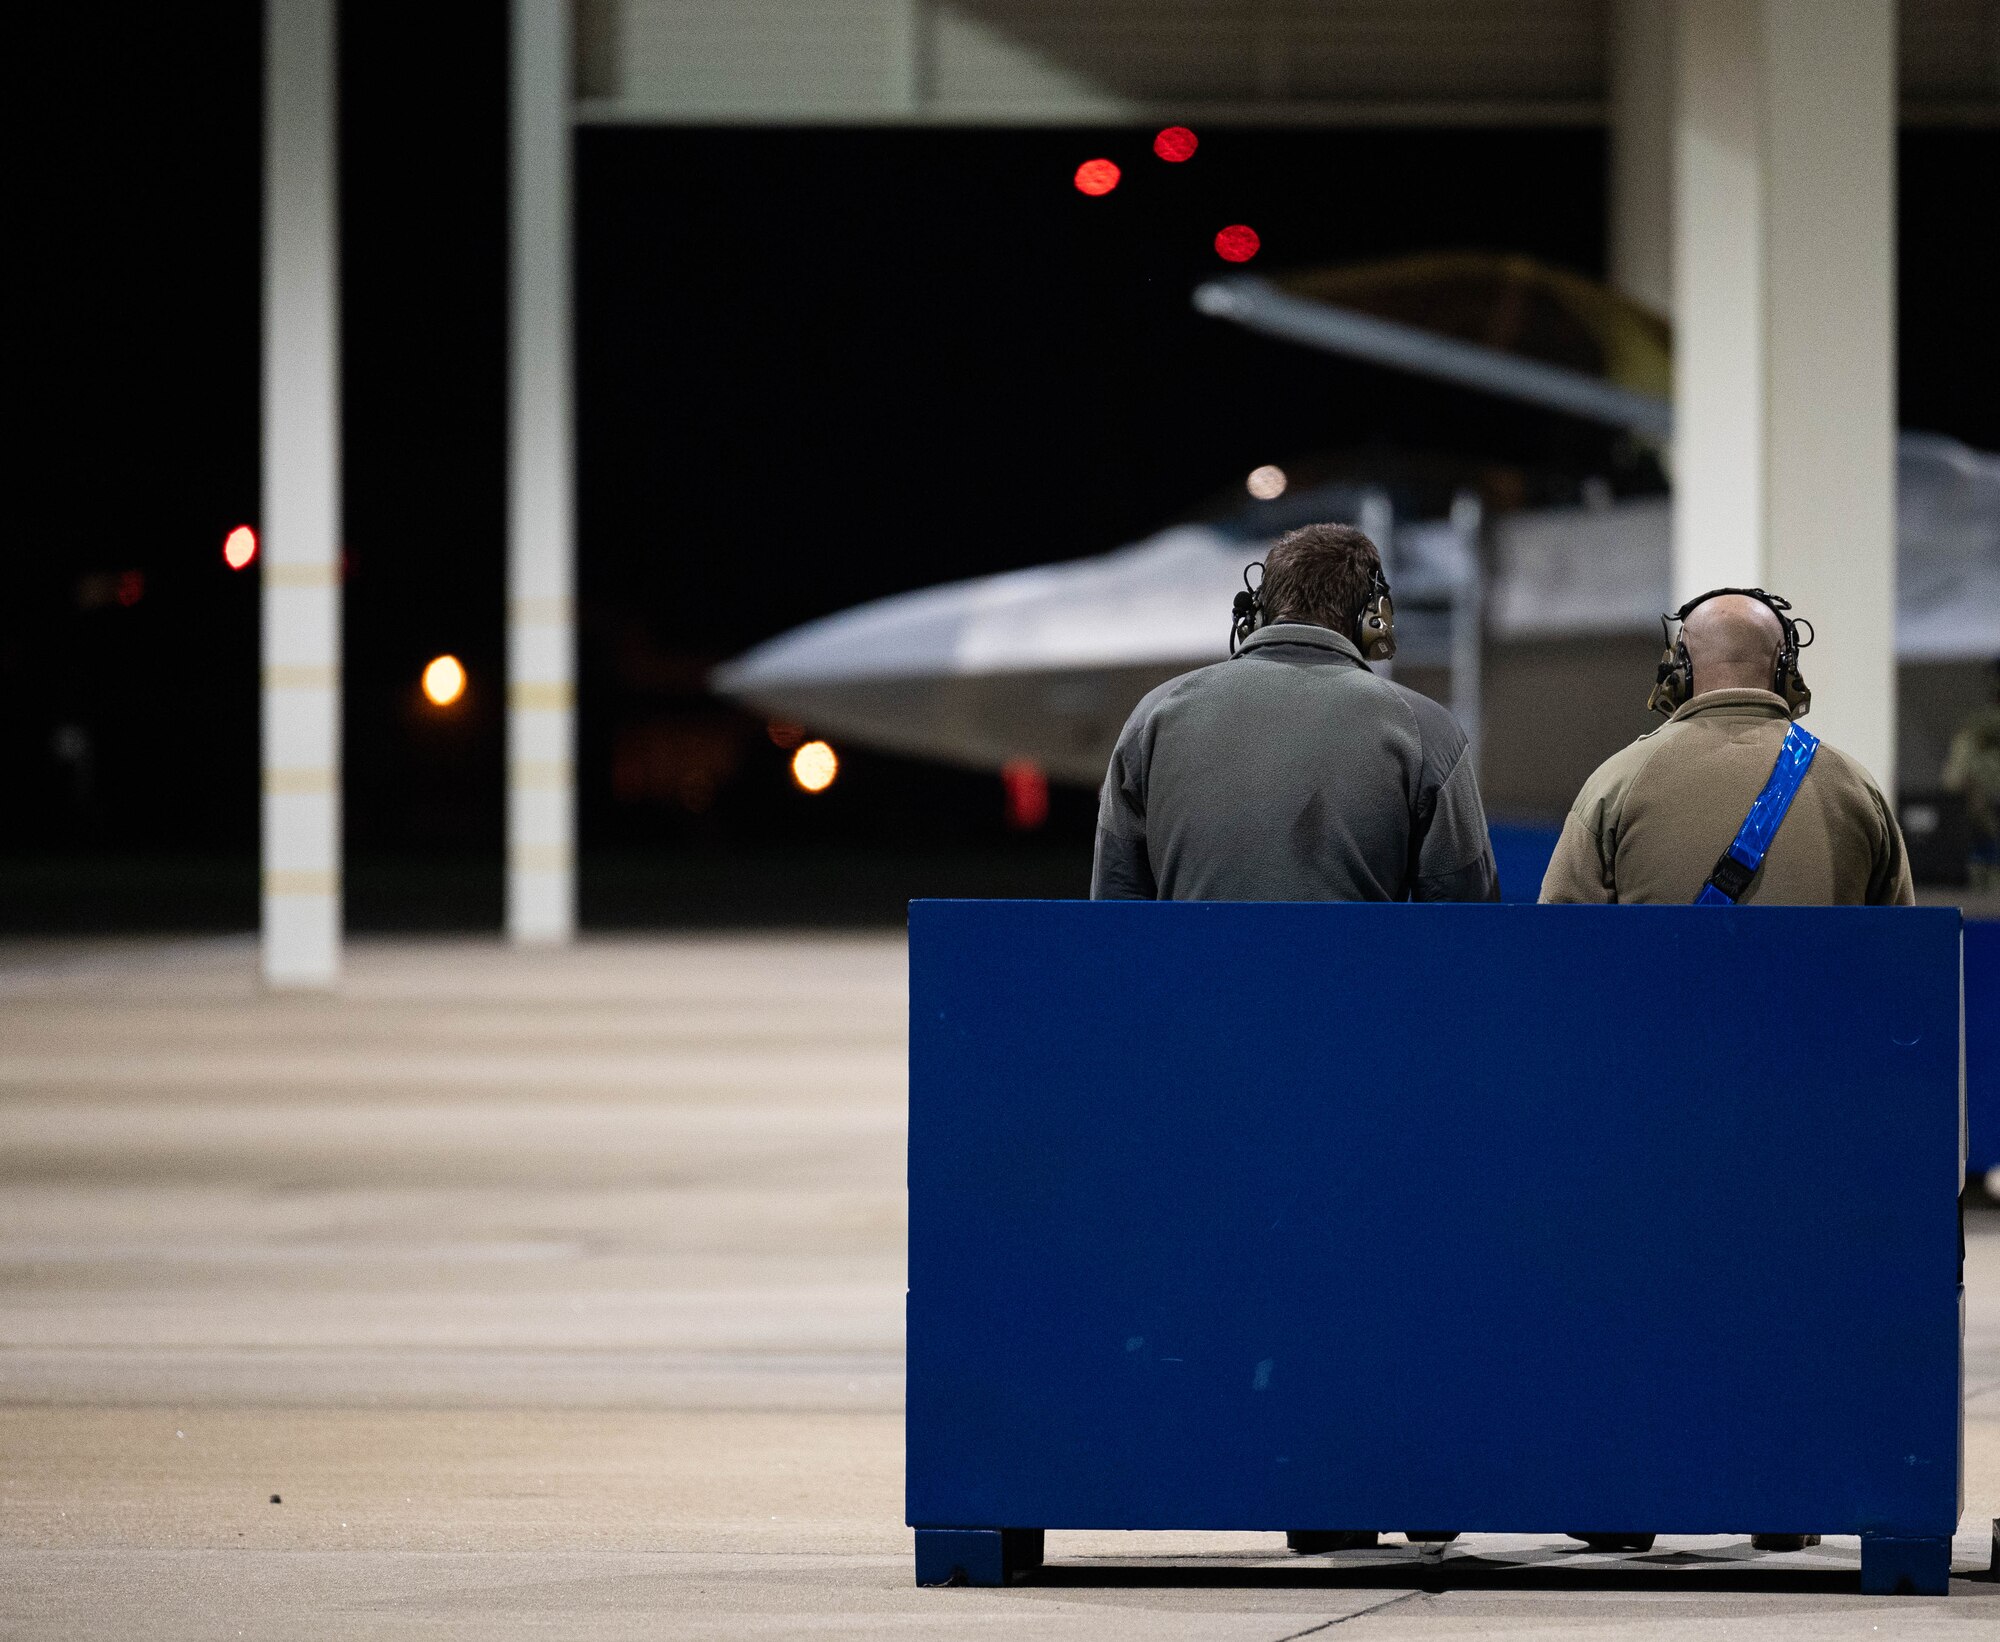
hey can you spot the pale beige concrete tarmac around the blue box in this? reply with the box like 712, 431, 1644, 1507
0, 936, 2000, 1642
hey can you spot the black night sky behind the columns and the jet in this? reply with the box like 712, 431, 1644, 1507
0, 4, 2000, 916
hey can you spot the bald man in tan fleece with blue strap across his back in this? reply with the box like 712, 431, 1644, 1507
1542, 590, 1914, 906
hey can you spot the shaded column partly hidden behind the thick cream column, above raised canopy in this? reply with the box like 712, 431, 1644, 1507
1606, 0, 1674, 314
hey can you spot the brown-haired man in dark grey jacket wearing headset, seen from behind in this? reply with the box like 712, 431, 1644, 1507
1090, 524, 1500, 900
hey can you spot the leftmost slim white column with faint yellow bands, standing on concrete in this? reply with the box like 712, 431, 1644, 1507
260, 0, 340, 986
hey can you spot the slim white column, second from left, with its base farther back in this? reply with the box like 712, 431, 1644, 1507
506, 0, 576, 942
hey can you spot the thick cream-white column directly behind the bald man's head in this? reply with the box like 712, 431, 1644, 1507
1674, 0, 1896, 790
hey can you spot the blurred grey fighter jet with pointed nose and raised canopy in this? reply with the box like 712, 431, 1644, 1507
710, 256, 2000, 786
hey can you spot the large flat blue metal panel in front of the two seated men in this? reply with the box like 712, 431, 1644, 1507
908, 902, 1958, 1534
